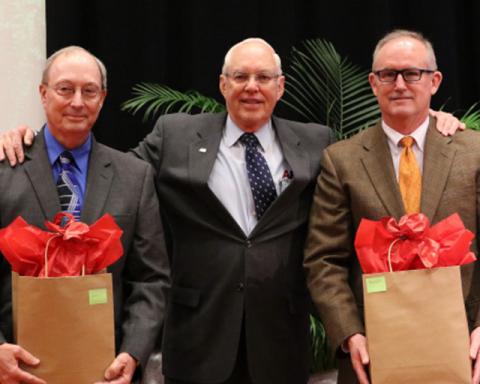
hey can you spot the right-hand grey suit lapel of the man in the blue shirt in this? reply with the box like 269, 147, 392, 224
81, 139, 114, 224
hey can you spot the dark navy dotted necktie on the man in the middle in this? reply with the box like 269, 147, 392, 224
240, 133, 277, 220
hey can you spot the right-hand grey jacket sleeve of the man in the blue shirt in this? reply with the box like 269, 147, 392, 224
120, 165, 170, 367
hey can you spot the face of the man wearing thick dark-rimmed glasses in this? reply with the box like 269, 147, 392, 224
369, 37, 442, 134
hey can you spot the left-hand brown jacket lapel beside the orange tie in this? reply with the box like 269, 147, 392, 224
362, 122, 405, 219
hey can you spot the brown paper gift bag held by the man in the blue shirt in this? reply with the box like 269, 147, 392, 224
12, 272, 115, 384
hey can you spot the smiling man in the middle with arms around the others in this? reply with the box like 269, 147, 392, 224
130, 39, 333, 384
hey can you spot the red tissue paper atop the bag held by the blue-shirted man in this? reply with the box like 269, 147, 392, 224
0, 212, 123, 277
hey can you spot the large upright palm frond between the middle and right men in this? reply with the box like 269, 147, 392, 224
283, 39, 380, 139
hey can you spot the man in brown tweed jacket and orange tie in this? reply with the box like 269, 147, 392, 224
304, 31, 480, 383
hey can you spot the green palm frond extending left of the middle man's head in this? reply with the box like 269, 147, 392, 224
122, 83, 225, 121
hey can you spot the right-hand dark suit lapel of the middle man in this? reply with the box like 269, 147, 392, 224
252, 117, 310, 236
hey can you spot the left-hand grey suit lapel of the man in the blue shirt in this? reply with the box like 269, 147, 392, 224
24, 134, 60, 220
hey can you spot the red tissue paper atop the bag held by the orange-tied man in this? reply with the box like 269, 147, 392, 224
355, 213, 476, 273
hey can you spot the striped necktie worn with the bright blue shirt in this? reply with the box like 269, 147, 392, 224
57, 151, 83, 221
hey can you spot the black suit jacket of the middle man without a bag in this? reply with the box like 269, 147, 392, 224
131, 113, 333, 384
